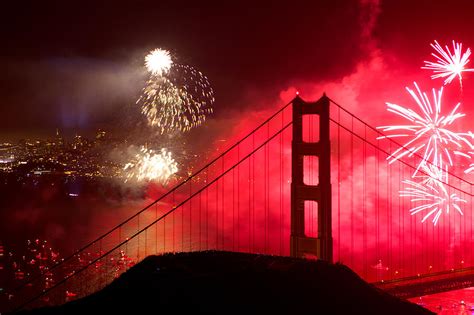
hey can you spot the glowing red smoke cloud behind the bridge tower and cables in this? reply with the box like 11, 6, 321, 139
7, 1, 474, 290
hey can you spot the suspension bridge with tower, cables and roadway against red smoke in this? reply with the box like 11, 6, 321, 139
4, 95, 474, 310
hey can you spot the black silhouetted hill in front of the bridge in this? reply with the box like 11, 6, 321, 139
22, 251, 433, 314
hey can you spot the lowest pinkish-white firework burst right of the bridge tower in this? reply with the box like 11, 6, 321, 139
400, 164, 466, 225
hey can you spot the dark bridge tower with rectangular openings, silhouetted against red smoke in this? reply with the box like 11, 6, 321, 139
290, 94, 333, 262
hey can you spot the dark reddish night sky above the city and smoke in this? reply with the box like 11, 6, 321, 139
0, 0, 474, 139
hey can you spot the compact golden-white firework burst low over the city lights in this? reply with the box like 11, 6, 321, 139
123, 147, 178, 184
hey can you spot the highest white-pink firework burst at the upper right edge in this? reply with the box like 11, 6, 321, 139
421, 41, 474, 87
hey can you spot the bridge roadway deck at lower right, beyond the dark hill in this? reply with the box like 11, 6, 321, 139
373, 267, 474, 299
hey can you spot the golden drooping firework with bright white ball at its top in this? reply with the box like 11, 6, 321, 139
137, 49, 214, 134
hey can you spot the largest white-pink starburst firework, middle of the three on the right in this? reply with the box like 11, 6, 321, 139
377, 82, 473, 175
